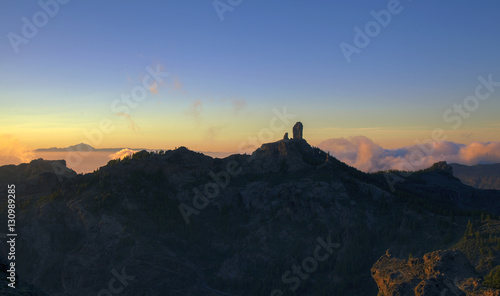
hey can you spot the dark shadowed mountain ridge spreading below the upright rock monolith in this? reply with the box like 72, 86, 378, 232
0, 139, 500, 296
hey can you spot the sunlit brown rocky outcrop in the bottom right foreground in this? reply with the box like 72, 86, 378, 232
371, 250, 499, 296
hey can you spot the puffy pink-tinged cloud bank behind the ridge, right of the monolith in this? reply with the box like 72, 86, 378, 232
318, 136, 500, 172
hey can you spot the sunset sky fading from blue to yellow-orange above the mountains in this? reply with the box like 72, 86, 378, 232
0, 0, 500, 170
